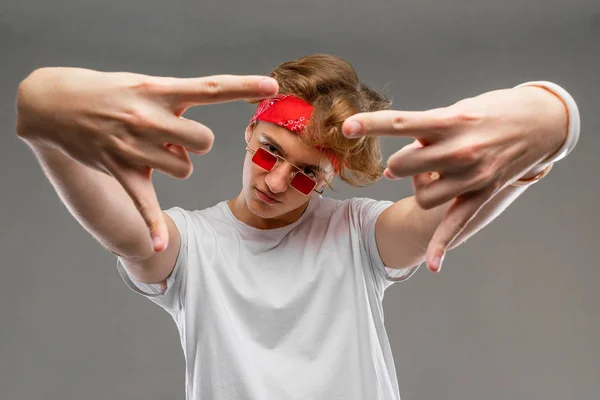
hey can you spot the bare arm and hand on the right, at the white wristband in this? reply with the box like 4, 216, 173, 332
345, 83, 578, 271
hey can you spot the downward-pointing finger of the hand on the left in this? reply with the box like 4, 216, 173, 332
108, 160, 169, 252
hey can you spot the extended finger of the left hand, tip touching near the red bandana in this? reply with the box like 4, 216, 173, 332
157, 75, 279, 108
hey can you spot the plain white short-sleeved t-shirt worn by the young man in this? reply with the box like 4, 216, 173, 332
117, 195, 418, 400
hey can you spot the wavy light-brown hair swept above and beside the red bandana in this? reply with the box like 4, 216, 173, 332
248, 54, 391, 187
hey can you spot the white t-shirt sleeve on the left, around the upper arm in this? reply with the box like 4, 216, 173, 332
117, 207, 190, 313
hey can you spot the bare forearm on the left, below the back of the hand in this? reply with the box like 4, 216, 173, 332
28, 143, 153, 259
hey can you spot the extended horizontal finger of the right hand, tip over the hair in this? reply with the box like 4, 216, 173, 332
342, 108, 462, 141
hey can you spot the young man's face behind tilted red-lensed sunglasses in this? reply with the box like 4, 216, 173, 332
243, 122, 333, 219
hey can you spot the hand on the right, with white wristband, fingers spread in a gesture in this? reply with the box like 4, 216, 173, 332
343, 87, 567, 271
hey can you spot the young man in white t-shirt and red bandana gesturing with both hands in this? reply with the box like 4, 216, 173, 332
17, 55, 579, 400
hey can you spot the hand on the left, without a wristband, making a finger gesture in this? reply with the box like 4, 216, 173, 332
17, 68, 278, 251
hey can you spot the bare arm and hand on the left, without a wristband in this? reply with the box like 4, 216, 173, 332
17, 68, 277, 283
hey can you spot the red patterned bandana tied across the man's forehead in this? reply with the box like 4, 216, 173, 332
250, 95, 339, 173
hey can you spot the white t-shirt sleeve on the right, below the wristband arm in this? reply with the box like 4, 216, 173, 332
352, 198, 421, 290
